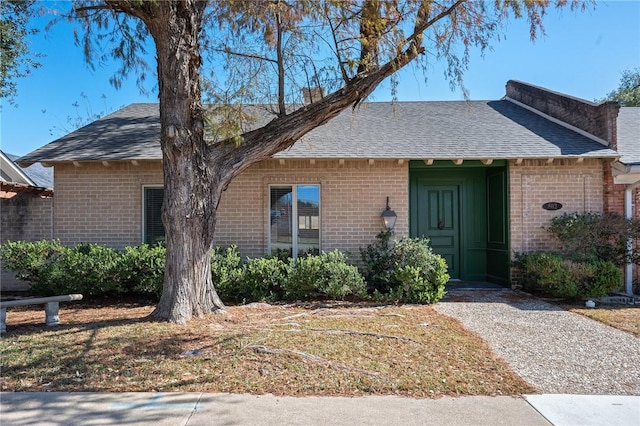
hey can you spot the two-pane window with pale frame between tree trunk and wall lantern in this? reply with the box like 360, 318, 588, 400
269, 185, 320, 257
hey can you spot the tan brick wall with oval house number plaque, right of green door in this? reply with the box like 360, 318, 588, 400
509, 160, 604, 252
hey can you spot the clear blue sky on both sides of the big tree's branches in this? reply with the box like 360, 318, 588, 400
0, 0, 640, 155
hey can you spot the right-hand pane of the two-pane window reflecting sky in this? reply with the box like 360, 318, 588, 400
296, 185, 320, 255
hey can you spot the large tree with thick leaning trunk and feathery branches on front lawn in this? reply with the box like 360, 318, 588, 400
20, 0, 594, 323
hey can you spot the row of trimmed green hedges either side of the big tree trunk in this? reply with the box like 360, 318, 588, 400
0, 233, 449, 303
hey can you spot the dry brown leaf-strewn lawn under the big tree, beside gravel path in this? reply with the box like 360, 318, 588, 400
1, 303, 535, 397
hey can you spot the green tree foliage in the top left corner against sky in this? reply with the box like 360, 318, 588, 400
0, 0, 40, 102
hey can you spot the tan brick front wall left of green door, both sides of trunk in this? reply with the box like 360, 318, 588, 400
54, 160, 409, 256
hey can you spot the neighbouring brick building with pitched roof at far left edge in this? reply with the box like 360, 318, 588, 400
0, 151, 53, 291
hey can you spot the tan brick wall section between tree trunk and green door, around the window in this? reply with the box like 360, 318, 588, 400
215, 160, 409, 256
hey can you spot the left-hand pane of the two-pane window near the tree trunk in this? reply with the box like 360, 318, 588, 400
269, 186, 293, 256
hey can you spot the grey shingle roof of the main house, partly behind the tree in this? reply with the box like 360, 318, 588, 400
20, 100, 618, 163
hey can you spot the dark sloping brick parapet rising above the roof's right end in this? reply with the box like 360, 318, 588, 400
506, 80, 620, 149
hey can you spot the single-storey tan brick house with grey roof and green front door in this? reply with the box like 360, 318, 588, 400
20, 81, 640, 292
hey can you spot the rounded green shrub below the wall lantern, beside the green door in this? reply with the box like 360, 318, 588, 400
360, 231, 449, 303
